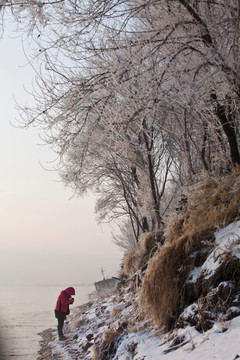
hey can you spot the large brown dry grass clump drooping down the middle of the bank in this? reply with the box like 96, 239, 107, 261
141, 238, 200, 330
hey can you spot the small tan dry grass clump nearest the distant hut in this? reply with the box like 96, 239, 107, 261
121, 232, 157, 277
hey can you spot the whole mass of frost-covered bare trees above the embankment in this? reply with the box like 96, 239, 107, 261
2, 0, 240, 243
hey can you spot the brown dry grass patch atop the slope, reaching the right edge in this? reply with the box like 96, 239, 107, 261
165, 166, 240, 242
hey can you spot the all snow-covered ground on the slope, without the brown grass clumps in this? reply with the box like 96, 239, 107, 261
38, 222, 240, 360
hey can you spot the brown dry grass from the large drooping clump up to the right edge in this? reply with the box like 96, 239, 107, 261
141, 167, 240, 330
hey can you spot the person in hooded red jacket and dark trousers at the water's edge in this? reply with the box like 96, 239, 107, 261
55, 287, 75, 340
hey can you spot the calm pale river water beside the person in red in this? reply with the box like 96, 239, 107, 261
0, 284, 94, 360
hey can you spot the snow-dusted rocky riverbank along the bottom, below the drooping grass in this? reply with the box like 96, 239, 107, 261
38, 293, 240, 360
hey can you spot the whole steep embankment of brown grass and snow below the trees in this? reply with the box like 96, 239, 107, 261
38, 169, 240, 360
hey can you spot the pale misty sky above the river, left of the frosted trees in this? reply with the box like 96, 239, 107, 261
0, 25, 122, 285
